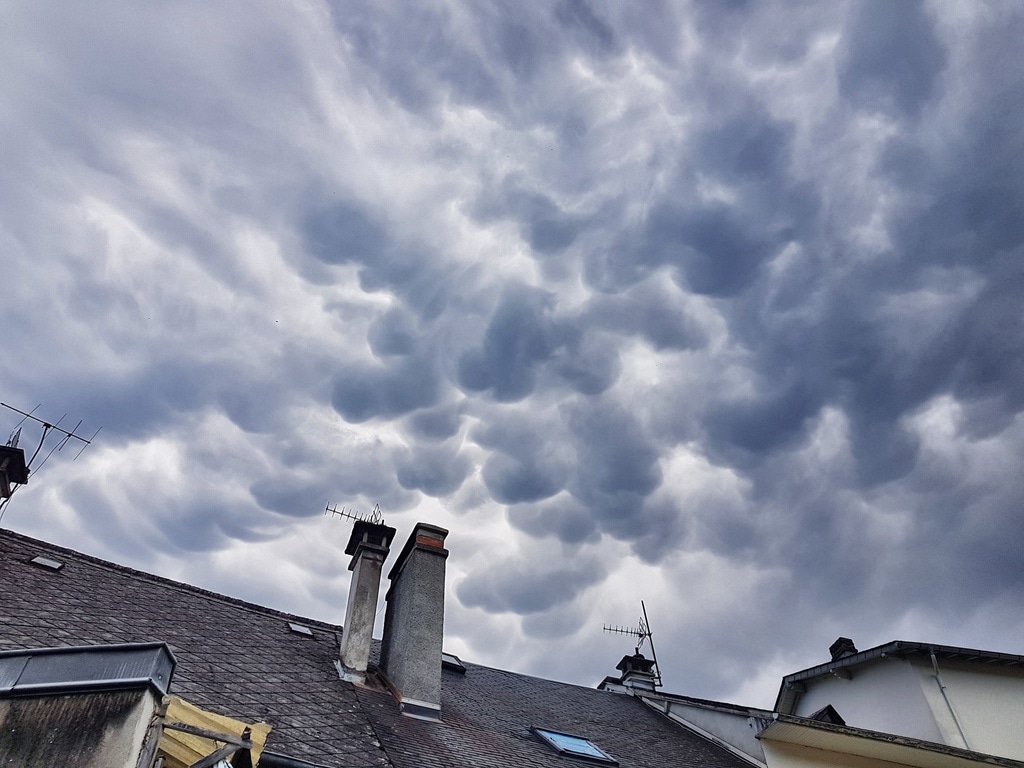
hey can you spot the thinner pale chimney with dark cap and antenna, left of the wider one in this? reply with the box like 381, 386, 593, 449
338, 520, 394, 683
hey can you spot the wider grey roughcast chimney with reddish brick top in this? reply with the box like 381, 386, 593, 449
380, 522, 447, 720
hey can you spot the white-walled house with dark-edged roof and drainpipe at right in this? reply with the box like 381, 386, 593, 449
760, 637, 1024, 767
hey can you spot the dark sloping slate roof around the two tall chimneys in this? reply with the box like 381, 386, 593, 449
0, 530, 750, 768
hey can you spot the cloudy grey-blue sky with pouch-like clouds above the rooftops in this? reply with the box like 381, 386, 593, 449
0, 0, 1024, 708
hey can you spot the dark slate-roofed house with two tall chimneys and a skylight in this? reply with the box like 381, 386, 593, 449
0, 522, 762, 768
